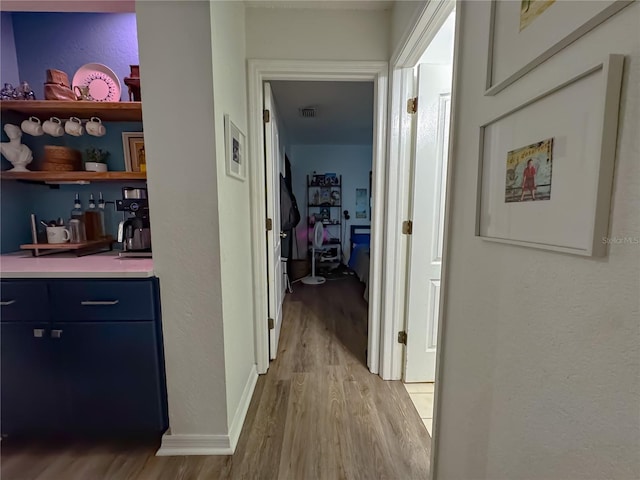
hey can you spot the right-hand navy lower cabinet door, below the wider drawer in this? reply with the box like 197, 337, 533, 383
57, 321, 167, 434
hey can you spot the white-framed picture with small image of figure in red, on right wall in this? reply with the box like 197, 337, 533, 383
476, 55, 624, 256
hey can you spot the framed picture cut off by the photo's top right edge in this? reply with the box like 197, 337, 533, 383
485, 0, 633, 95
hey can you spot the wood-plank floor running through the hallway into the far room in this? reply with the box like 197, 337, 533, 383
0, 278, 431, 480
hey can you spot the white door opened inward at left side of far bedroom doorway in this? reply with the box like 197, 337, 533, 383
264, 83, 286, 360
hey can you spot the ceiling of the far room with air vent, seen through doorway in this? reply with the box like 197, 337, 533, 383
270, 81, 373, 145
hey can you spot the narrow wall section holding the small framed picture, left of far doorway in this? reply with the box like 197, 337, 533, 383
211, 1, 255, 425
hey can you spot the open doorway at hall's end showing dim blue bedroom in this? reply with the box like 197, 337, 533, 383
264, 80, 374, 368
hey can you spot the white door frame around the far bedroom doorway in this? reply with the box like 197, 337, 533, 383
247, 60, 392, 378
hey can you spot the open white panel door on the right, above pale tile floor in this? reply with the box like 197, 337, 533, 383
404, 65, 452, 382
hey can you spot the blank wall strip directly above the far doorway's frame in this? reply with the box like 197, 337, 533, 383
247, 8, 390, 62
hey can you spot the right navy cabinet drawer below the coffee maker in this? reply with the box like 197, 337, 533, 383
49, 280, 155, 322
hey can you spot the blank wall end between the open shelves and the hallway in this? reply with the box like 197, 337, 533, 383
136, 1, 228, 434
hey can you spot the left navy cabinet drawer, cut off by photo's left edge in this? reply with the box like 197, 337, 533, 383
0, 281, 49, 322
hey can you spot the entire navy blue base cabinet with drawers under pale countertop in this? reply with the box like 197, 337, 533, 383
0, 279, 168, 436
